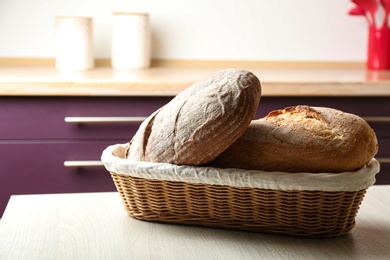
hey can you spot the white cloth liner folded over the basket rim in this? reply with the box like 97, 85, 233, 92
101, 144, 380, 191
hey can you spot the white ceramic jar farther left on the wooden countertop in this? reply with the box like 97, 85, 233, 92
55, 16, 94, 71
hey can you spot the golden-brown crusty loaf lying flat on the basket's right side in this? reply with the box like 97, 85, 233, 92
211, 106, 378, 172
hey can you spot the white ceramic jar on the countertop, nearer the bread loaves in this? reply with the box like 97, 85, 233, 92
111, 12, 151, 70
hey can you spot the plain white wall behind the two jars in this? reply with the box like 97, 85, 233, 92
0, 0, 368, 61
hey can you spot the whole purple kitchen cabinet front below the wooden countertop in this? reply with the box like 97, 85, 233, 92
0, 96, 390, 216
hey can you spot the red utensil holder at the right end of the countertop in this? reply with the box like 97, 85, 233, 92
367, 26, 390, 70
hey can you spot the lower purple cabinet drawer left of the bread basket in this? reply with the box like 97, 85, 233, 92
0, 139, 122, 216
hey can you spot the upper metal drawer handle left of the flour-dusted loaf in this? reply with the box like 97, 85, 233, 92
64, 116, 147, 124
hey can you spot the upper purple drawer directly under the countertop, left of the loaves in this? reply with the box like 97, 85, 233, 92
0, 97, 170, 140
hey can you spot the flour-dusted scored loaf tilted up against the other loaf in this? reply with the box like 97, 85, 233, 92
127, 69, 261, 165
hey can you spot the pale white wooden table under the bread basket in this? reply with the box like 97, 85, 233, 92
0, 185, 390, 260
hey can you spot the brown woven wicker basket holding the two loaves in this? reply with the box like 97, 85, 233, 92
102, 146, 379, 237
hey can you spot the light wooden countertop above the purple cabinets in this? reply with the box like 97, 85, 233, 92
0, 66, 390, 96
